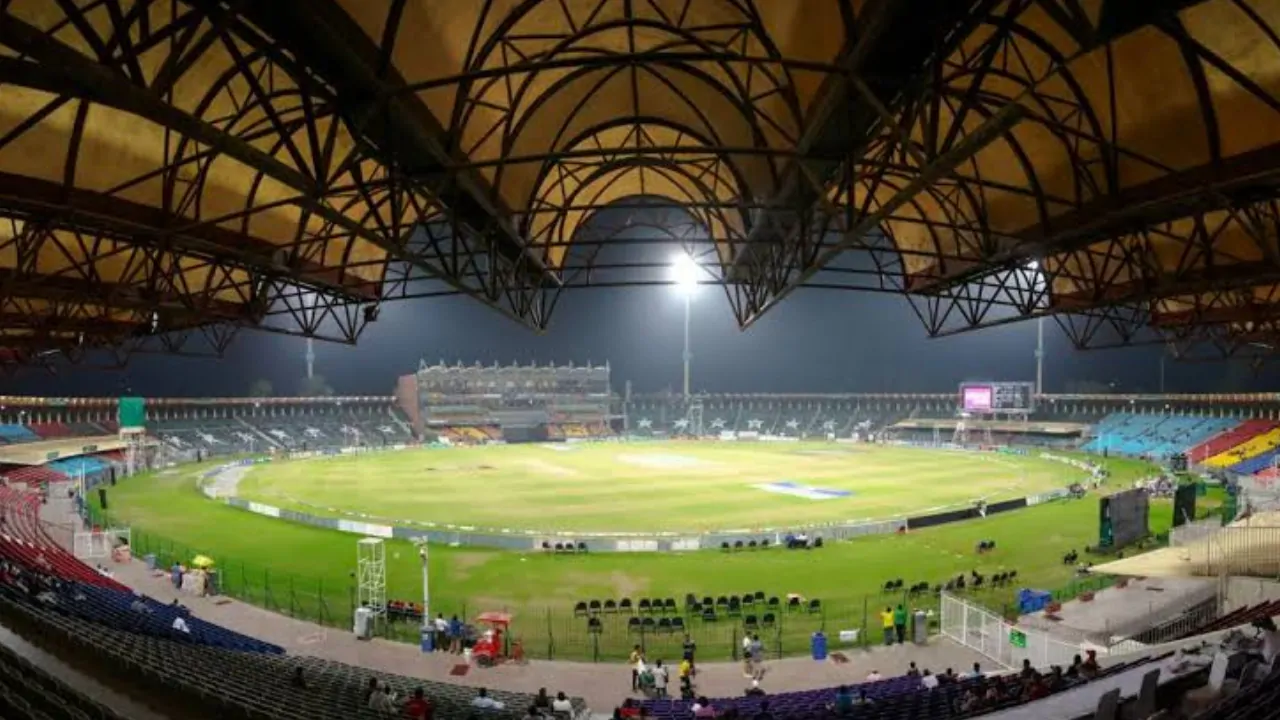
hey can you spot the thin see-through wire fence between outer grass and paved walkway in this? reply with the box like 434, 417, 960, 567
87, 505, 1112, 662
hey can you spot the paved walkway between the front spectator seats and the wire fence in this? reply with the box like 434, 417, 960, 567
41, 479, 989, 712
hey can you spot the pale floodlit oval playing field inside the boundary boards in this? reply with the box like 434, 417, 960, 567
239, 442, 1085, 532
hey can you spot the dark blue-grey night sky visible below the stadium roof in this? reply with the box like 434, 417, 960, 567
0, 287, 1259, 397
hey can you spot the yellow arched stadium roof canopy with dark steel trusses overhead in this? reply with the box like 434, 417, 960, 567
0, 0, 1280, 365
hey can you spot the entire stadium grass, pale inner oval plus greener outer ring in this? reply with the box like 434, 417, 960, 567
90, 445, 1187, 659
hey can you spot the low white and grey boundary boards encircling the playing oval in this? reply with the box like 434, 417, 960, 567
202, 446, 1087, 552
